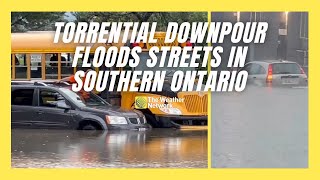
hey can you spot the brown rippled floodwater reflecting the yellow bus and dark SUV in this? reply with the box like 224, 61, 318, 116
11, 129, 208, 168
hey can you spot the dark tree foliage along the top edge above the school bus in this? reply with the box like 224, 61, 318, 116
11, 12, 207, 32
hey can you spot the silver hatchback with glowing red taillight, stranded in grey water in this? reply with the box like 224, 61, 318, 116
240, 60, 308, 86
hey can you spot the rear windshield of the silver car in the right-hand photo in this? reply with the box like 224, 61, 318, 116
272, 63, 302, 74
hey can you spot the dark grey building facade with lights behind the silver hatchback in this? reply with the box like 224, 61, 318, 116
211, 12, 308, 68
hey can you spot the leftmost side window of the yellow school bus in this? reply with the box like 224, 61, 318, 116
15, 54, 28, 79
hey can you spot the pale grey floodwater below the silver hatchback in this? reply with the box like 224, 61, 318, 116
211, 86, 308, 168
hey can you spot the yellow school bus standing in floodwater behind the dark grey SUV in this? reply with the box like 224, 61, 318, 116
11, 32, 208, 129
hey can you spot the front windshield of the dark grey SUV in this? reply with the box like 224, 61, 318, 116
61, 88, 110, 107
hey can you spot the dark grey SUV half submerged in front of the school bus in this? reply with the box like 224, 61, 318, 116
11, 81, 150, 130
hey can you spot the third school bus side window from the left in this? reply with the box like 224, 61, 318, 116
45, 54, 58, 79
